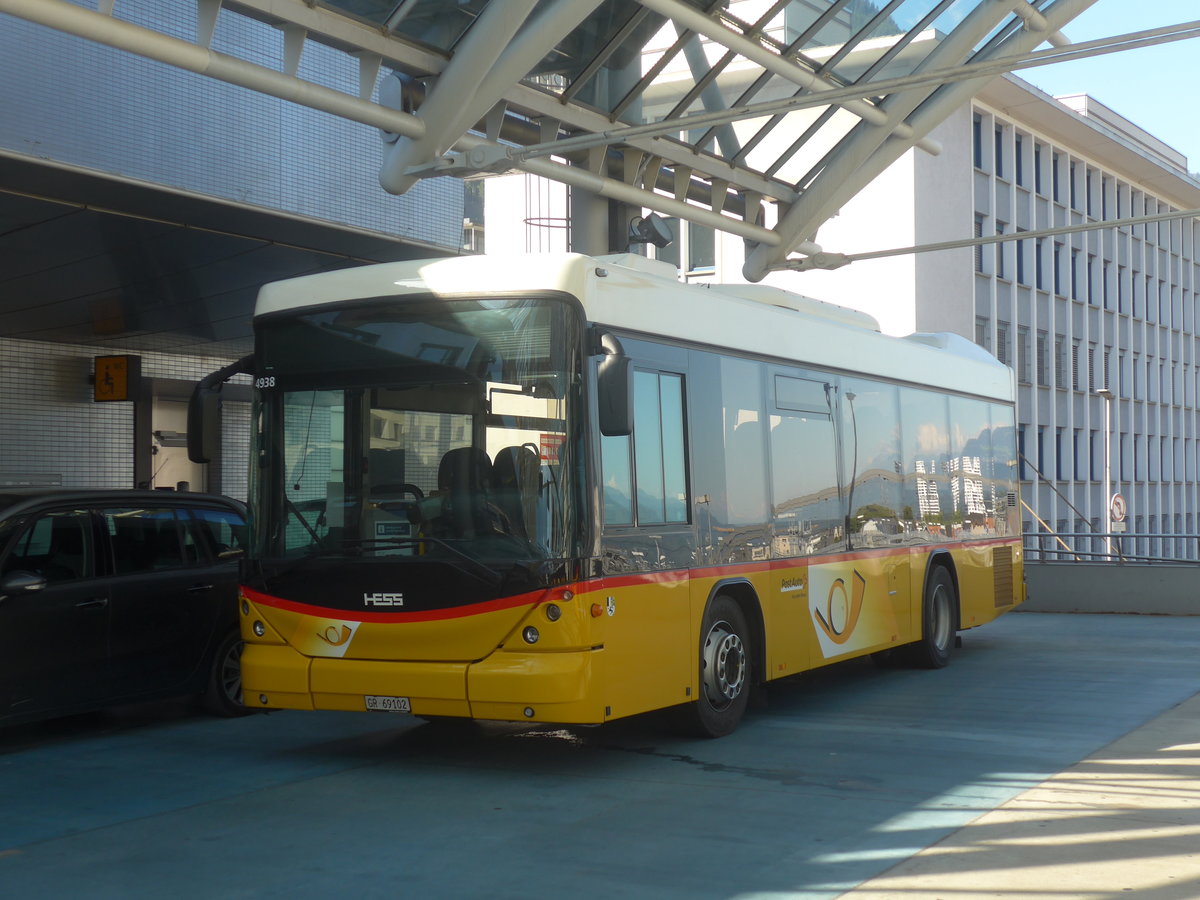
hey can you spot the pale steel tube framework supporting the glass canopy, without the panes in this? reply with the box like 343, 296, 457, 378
0, 0, 1128, 270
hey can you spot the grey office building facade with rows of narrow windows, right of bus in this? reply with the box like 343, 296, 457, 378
970, 79, 1200, 559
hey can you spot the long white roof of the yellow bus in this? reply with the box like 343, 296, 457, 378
254, 253, 1014, 401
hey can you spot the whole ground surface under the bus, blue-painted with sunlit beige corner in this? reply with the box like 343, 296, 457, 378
0, 613, 1200, 900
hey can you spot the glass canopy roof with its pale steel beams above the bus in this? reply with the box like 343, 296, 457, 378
11, 0, 1094, 281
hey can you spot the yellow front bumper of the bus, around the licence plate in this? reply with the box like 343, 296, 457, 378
241, 642, 607, 725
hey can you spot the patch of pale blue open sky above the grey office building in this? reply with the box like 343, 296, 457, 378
1015, 0, 1200, 173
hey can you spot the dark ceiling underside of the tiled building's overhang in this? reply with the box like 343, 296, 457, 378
0, 156, 428, 358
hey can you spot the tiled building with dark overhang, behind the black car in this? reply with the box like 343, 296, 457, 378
0, 0, 463, 498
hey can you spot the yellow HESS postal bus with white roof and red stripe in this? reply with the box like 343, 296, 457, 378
192, 254, 1024, 736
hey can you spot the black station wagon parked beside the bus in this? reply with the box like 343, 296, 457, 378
0, 488, 246, 725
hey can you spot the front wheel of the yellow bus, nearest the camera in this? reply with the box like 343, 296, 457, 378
686, 594, 754, 738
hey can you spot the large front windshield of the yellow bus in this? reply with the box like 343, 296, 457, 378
252, 298, 582, 564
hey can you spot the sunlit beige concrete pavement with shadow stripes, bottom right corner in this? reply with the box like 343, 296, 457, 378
844, 696, 1200, 900
